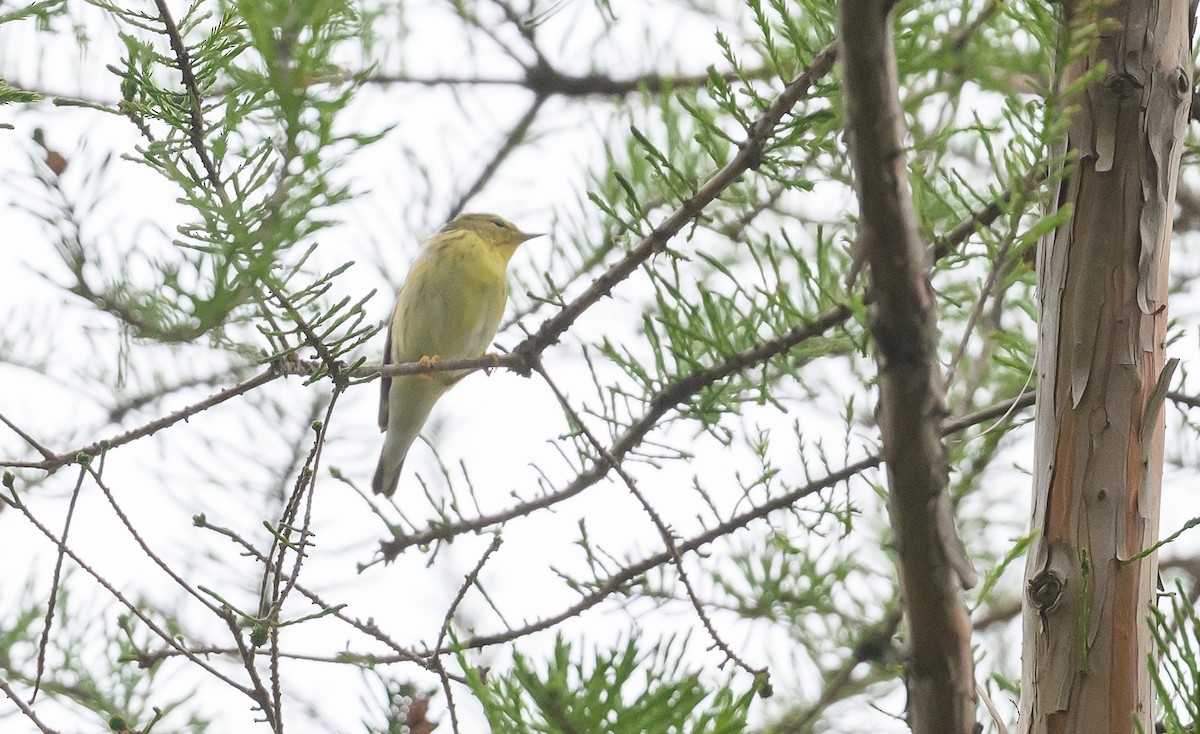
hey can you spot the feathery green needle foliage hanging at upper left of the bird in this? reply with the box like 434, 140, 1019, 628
25, 0, 378, 368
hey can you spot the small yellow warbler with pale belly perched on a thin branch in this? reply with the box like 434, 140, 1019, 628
371, 213, 541, 497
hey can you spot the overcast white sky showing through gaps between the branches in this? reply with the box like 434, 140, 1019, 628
7, 0, 1198, 732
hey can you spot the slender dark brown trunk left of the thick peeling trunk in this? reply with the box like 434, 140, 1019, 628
838, 0, 976, 734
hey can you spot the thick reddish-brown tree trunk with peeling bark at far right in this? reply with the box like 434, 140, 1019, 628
1021, 0, 1192, 734
